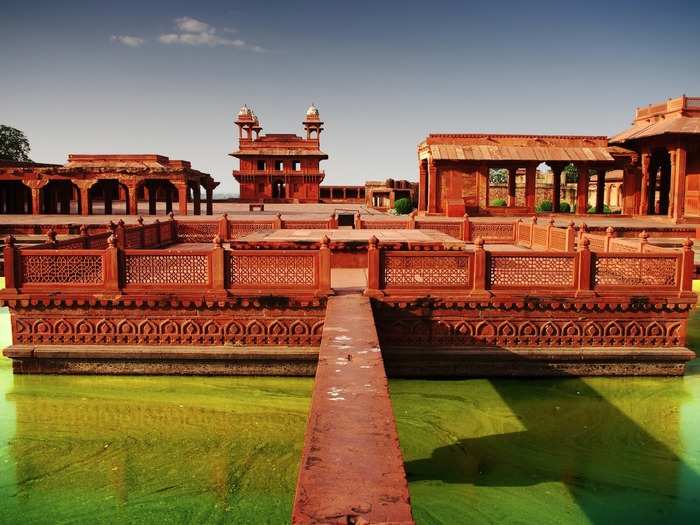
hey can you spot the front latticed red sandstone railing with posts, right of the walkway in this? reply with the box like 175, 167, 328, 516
366, 236, 695, 297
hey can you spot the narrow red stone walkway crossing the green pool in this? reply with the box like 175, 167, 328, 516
292, 294, 413, 525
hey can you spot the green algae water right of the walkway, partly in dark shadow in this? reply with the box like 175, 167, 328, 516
390, 320, 700, 524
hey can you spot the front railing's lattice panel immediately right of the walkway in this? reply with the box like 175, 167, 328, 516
382, 253, 470, 288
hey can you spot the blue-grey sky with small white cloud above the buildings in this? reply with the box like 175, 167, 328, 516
0, 0, 700, 191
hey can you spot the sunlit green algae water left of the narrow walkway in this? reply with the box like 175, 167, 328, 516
0, 298, 313, 524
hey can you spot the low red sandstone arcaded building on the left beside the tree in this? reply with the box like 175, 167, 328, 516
0, 154, 219, 215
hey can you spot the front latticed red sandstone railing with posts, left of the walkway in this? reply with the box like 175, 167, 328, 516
3, 233, 331, 297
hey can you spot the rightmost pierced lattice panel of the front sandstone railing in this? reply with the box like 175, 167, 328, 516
593, 255, 678, 286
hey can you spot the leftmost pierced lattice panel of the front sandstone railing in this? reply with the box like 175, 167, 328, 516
22, 254, 104, 284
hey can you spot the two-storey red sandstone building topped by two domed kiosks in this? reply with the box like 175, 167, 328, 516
231, 104, 328, 203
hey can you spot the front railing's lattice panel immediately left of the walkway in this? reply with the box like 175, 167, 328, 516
229, 251, 316, 287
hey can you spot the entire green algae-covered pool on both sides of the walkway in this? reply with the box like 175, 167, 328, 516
0, 298, 700, 524
